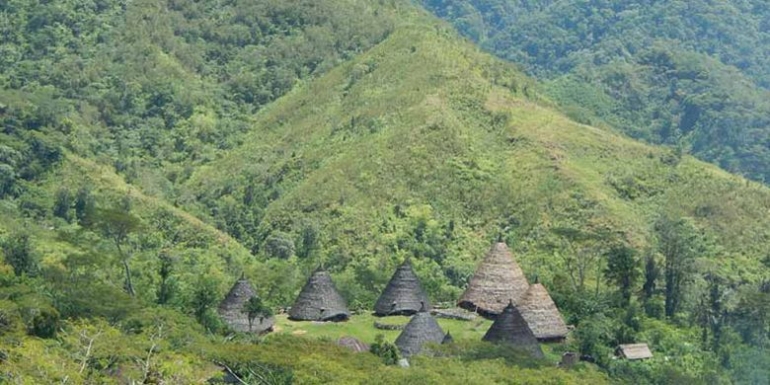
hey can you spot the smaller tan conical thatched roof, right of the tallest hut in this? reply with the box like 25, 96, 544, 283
516, 283, 567, 341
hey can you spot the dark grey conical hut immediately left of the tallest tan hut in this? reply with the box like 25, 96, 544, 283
374, 259, 430, 316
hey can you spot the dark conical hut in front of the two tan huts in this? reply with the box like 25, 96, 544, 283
483, 301, 544, 358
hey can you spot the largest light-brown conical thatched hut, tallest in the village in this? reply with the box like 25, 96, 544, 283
457, 242, 529, 319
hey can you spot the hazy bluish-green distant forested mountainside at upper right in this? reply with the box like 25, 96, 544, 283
423, 0, 770, 181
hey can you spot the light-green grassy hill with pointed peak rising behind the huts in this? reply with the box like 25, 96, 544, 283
186, 17, 770, 301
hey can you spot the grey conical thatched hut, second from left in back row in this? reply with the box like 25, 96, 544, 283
289, 268, 350, 322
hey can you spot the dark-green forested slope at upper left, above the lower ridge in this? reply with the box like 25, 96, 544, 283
0, 0, 398, 198
